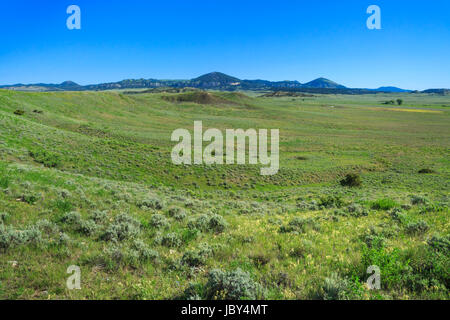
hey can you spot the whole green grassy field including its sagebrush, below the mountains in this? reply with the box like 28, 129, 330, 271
0, 90, 450, 299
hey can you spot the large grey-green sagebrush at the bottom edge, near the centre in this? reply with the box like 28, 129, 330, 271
204, 269, 264, 300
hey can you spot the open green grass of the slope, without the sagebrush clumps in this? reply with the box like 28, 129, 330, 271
0, 91, 450, 299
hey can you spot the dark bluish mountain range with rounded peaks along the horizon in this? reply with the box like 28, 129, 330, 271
0, 72, 444, 94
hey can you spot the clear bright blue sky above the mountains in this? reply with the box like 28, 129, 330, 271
0, 0, 450, 89
